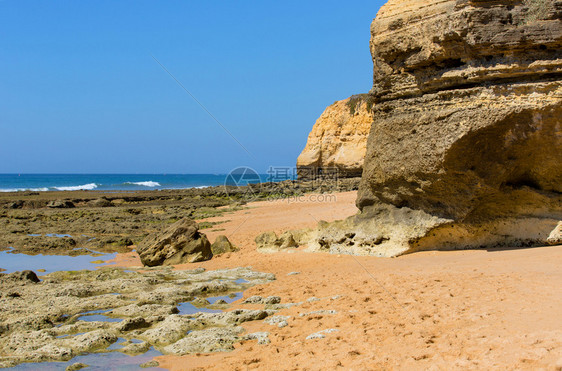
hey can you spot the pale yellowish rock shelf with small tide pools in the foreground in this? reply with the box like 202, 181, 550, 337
0, 268, 281, 367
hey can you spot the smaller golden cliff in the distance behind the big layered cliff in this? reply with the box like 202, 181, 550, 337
297, 94, 373, 178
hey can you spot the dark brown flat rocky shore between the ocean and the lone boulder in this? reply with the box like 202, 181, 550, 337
0, 178, 359, 260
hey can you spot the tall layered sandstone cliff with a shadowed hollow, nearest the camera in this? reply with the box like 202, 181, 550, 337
312, 0, 562, 256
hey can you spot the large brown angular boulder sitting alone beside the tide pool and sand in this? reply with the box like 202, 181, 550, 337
137, 218, 213, 267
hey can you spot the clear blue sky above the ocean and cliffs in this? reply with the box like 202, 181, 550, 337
0, 0, 383, 173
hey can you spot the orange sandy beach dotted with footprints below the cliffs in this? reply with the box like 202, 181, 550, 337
109, 192, 562, 370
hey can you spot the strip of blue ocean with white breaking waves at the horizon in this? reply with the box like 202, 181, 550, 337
0, 174, 267, 192
